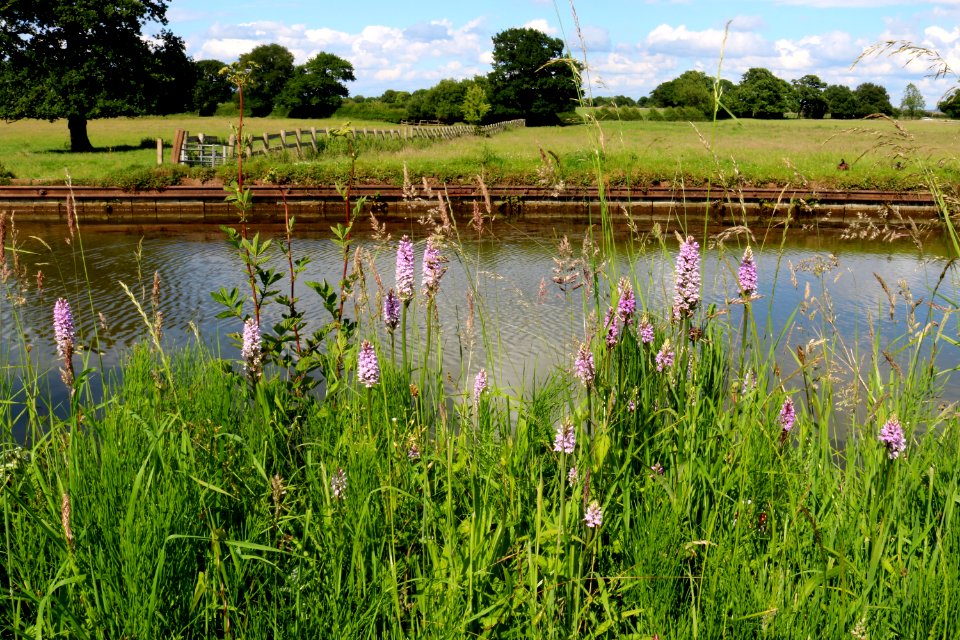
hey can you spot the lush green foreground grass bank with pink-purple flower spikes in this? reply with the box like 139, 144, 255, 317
0, 199, 960, 639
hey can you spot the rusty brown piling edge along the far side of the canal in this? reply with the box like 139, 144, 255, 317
0, 185, 938, 230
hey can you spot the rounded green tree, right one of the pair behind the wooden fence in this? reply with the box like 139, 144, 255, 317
276, 51, 356, 118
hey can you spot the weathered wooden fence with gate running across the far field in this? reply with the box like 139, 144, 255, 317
171, 120, 526, 167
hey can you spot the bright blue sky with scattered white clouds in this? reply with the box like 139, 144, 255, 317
167, 0, 960, 108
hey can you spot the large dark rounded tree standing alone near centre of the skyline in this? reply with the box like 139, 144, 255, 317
488, 28, 579, 126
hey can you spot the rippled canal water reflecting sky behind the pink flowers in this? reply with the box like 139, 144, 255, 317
0, 219, 960, 436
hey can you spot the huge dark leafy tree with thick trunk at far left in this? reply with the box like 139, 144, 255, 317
0, 0, 168, 151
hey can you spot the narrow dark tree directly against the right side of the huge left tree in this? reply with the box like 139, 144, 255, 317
146, 30, 195, 116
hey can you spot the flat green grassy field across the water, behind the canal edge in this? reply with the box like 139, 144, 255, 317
0, 116, 960, 189
